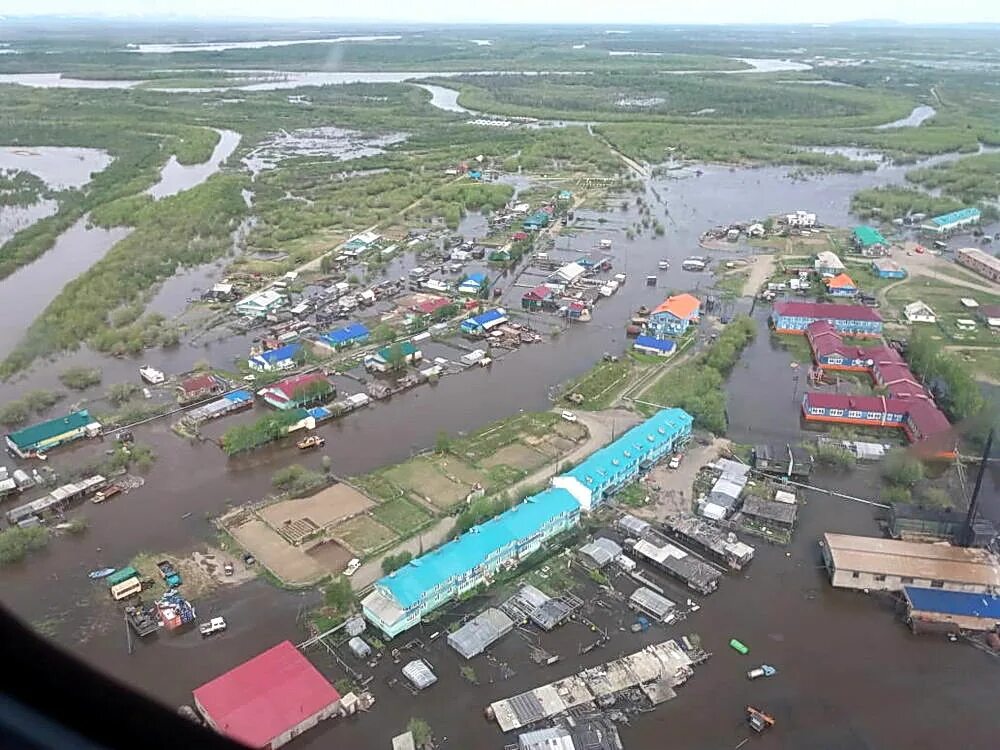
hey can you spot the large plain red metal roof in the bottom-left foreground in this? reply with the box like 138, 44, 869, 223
194, 641, 340, 748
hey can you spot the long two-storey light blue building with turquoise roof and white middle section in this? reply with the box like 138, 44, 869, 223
361, 409, 693, 638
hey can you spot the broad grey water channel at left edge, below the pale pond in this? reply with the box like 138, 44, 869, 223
0, 217, 129, 356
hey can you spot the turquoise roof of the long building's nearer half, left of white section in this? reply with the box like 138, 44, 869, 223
378, 488, 580, 608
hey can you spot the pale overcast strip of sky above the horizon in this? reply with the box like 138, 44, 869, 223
0, 0, 1000, 24
